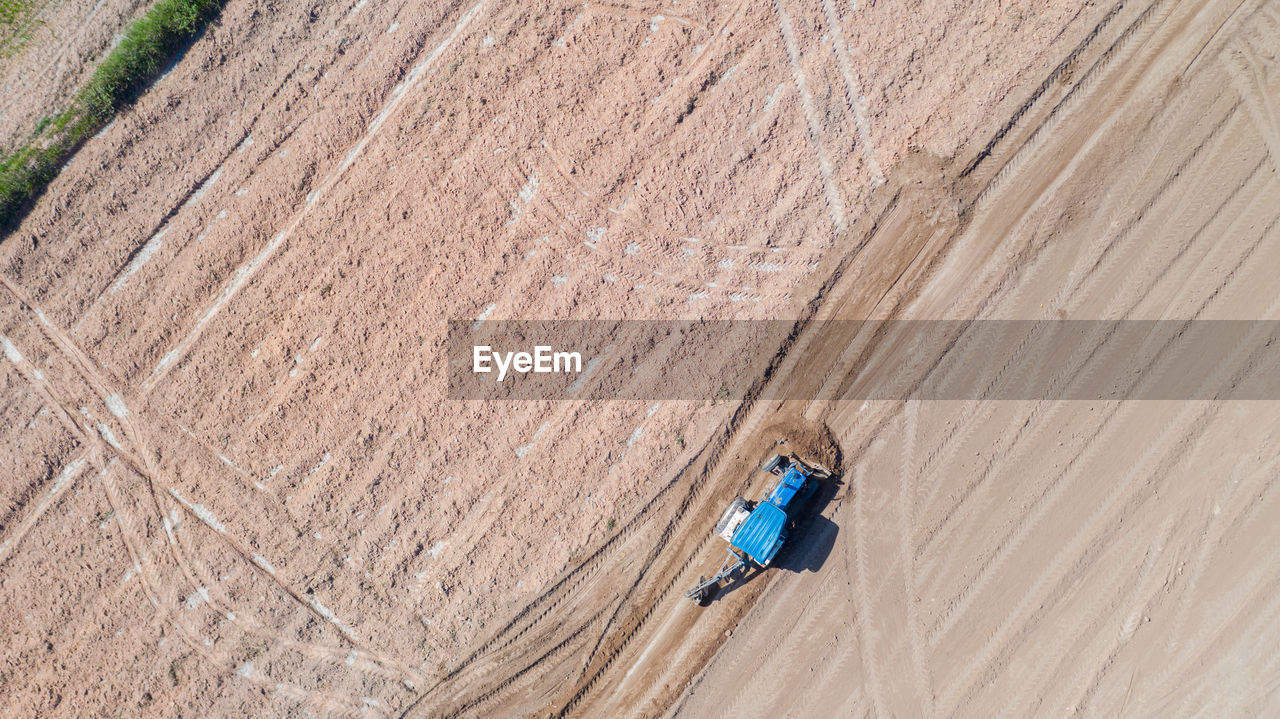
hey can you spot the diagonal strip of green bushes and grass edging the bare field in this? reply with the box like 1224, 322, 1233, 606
0, 0, 225, 232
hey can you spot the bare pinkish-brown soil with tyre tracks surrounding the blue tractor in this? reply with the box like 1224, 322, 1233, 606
0, 0, 1280, 716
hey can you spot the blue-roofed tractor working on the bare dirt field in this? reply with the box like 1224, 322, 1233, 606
685, 454, 829, 604
